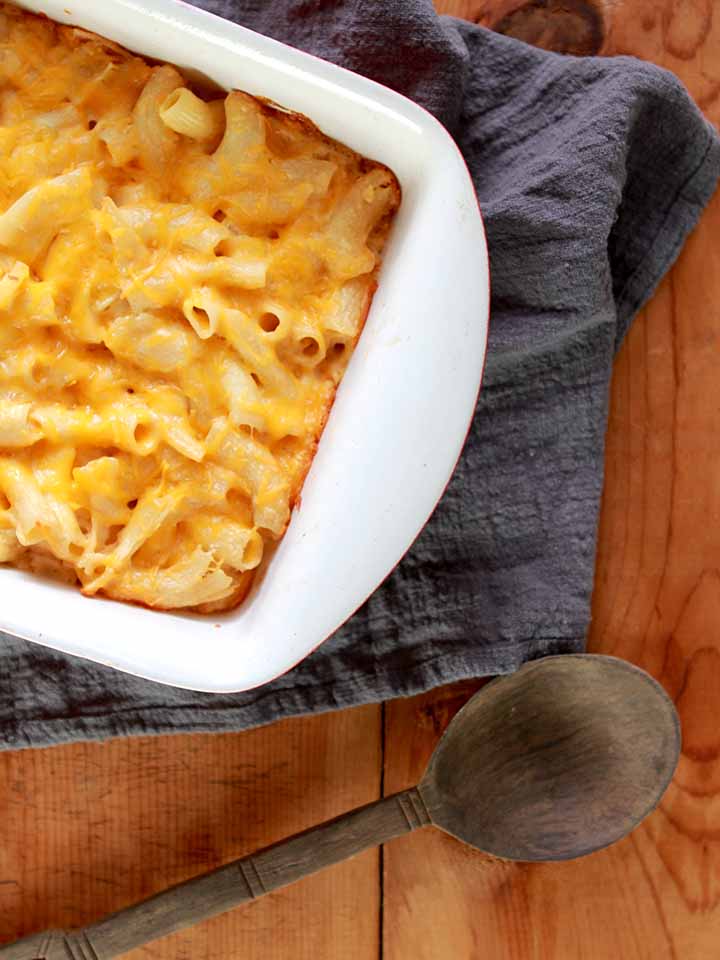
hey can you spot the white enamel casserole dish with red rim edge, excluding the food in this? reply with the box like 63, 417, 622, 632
0, 0, 489, 692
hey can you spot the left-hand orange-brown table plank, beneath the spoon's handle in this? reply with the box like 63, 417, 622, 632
0, 707, 381, 960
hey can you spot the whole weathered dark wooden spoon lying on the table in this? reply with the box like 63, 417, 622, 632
0, 655, 680, 960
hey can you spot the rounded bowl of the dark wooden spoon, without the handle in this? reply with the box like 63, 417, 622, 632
419, 654, 680, 861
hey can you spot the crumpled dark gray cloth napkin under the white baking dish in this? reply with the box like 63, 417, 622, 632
0, 0, 720, 748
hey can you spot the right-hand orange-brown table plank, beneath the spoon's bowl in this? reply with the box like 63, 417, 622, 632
384, 0, 720, 960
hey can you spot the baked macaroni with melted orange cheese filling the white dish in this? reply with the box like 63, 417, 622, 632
0, 4, 400, 612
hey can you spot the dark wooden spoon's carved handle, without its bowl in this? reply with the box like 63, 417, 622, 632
0, 787, 431, 960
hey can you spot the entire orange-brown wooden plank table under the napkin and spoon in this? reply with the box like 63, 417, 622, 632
0, 0, 720, 960
